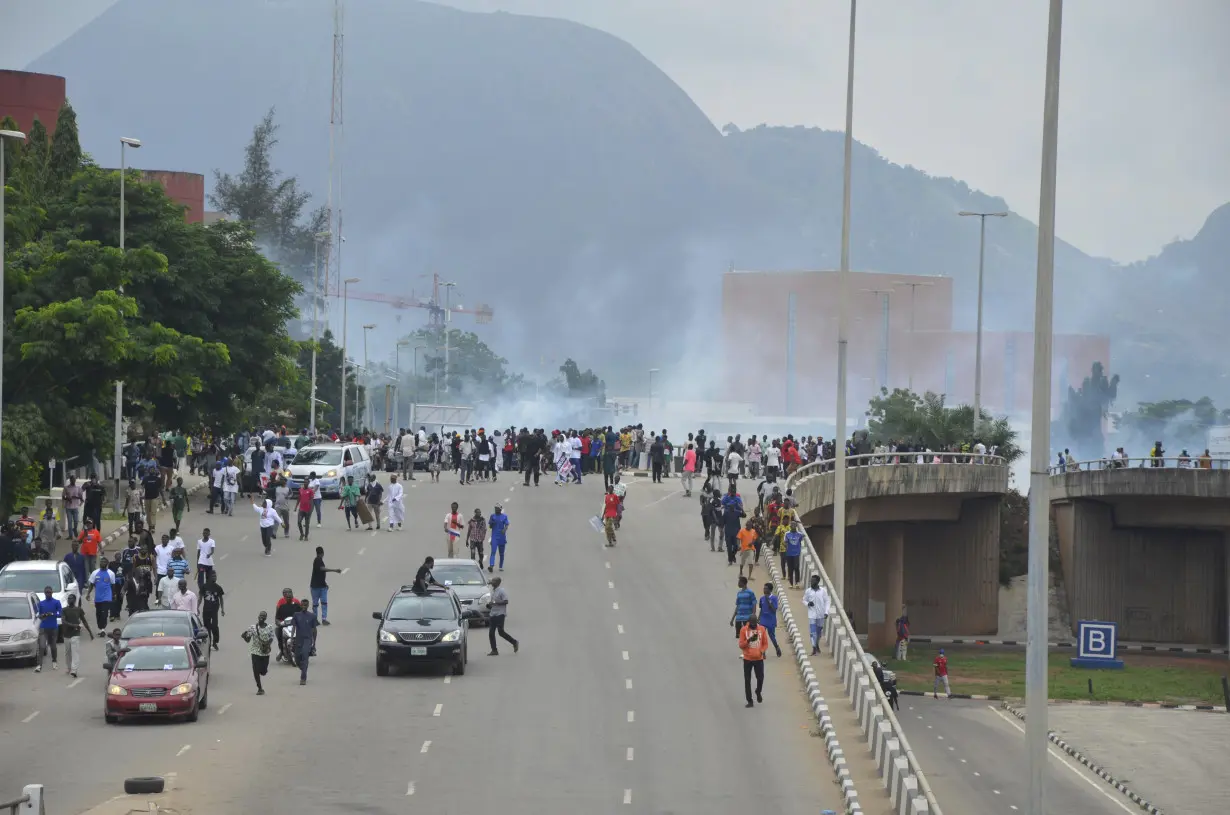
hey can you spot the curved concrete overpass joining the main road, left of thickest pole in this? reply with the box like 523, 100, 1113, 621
788, 452, 1009, 648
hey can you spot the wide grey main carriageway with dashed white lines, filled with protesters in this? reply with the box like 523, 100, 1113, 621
0, 473, 839, 815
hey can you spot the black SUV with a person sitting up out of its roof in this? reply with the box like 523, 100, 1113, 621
371, 586, 477, 676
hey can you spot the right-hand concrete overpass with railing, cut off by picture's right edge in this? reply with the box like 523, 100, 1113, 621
1047, 457, 1230, 644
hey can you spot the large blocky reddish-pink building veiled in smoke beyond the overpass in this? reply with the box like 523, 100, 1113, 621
722, 272, 1111, 417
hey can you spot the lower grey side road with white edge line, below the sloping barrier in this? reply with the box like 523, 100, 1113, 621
898, 696, 1140, 815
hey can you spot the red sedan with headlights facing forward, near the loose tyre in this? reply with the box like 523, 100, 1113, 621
103, 637, 209, 724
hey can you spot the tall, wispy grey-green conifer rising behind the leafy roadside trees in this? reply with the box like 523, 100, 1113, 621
209, 108, 328, 283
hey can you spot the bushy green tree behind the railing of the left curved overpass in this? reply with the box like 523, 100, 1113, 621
867, 387, 1022, 461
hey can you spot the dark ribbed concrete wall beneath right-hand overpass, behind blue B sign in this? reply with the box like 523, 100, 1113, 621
1052, 503, 1228, 644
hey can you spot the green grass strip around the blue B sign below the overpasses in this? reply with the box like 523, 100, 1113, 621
877, 644, 1230, 704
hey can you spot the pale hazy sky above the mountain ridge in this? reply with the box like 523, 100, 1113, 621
0, 0, 1230, 261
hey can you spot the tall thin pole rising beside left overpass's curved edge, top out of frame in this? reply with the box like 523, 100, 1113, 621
829, 0, 859, 597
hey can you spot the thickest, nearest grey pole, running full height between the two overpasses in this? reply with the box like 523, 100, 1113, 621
1025, 0, 1064, 815
